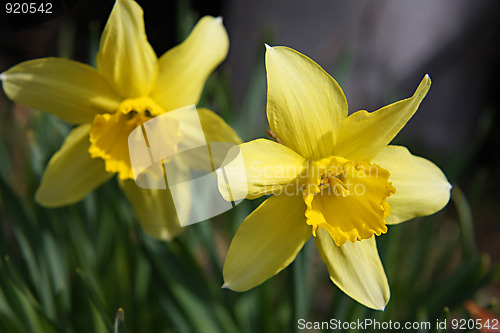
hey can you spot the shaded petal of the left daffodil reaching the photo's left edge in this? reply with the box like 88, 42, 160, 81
0, 58, 120, 124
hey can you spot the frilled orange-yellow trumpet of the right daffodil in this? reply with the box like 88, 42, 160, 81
303, 156, 396, 246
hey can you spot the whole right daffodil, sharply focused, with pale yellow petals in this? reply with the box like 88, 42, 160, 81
219, 47, 451, 309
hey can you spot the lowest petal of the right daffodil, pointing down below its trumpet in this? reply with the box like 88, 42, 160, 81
314, 229, 390, 310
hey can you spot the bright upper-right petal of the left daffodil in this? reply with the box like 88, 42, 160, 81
151, 16, 229, 111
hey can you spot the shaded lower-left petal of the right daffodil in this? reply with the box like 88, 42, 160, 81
223, 195, 311, 291
